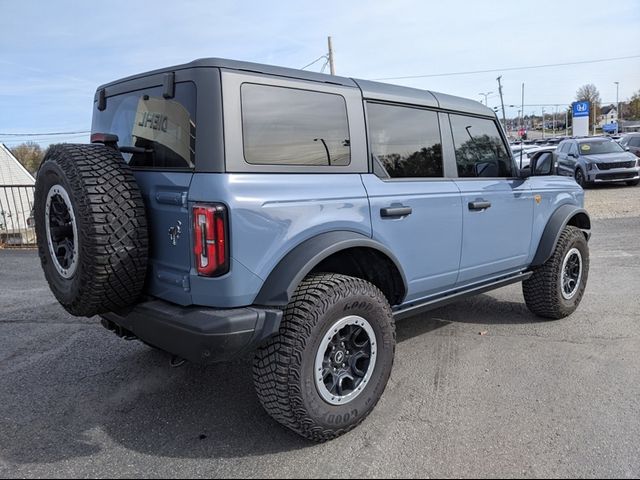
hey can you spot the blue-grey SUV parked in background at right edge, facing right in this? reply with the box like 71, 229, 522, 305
556, 137, 640, 186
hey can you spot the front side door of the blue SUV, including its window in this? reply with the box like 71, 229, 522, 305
449, 114, 533, 286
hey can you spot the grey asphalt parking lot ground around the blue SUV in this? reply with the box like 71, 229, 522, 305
0, 187, 640, 478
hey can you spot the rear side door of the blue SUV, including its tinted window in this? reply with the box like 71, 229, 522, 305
362, 102, 462, 302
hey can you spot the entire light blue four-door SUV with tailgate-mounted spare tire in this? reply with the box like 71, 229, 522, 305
35, 59, 591, 441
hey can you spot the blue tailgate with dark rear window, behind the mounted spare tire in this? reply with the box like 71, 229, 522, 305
92, 82, 196, 305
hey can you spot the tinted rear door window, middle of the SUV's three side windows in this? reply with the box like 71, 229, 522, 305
367, 103, 443, 178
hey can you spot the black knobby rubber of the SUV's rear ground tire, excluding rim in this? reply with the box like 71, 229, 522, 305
253, 273, 395, 442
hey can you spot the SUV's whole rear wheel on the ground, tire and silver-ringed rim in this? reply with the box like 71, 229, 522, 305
253, 273, 395, 442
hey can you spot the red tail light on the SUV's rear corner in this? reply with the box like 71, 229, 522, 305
193, 204, 229, 277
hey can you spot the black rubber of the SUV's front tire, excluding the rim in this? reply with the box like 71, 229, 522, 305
522, 226, 589, 320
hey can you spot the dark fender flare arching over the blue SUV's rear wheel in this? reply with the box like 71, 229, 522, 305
254, 231, 407, 307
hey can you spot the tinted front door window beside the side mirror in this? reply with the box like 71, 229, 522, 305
449, 114, 514, 177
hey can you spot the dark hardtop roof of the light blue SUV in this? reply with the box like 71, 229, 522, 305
98, 58, 495, 116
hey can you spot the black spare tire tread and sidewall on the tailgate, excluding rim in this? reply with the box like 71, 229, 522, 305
34, 144, 149, 317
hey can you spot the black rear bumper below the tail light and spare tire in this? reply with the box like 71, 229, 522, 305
102, 299, 282, 364
